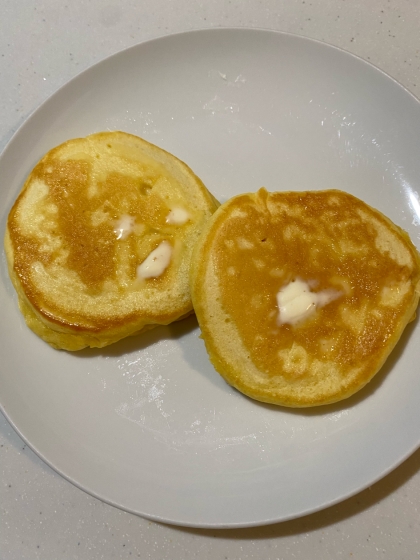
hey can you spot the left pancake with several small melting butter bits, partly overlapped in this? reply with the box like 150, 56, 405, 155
5, 132, 218, 350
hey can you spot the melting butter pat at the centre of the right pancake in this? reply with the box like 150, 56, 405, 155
277, 280, 341, 325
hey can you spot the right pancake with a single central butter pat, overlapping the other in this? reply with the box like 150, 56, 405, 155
190, 189, 420, 407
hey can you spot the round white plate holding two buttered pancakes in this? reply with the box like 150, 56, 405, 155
0, 29, 420, 527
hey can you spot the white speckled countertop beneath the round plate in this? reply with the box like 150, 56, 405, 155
0, 0, 420, 560
